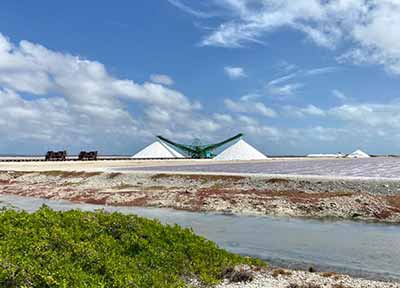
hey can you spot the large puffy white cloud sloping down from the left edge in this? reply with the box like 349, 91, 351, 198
0, 34, 203, 150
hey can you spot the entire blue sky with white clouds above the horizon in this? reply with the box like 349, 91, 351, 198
0, 0, 400, 155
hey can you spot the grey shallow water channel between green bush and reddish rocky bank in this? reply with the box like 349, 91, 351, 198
0, 195, 400, 281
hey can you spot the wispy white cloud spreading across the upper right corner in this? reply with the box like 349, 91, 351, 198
173, 0, 400, 74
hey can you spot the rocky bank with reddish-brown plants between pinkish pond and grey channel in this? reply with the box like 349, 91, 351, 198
0, 171, 400, 223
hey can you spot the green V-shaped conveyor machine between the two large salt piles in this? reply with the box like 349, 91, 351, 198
157, 133, 243, 159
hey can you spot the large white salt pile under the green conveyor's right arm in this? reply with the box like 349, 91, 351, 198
214, 140, 267, 160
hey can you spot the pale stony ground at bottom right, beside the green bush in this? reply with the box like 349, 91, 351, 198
216, 266, 400, 288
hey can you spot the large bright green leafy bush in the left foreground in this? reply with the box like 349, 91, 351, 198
0, 206, 265, 288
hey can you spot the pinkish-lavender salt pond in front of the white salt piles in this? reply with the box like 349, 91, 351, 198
113, 158, 400, 178
